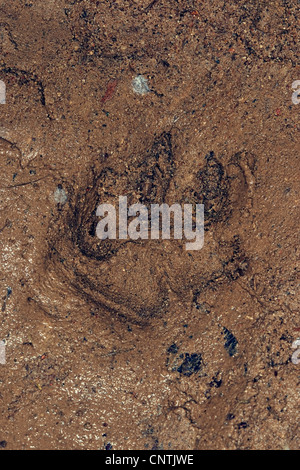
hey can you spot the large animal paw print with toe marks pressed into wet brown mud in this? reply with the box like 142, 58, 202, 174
32, 133, 253, 324
